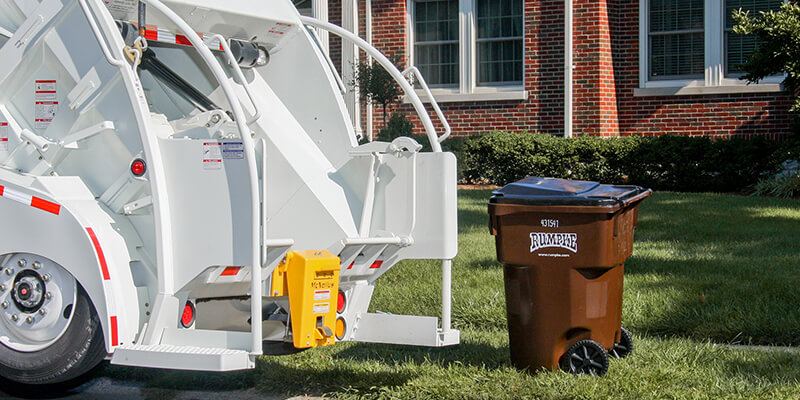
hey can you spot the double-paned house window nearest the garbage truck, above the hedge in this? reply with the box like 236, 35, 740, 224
408, 0, 523, 94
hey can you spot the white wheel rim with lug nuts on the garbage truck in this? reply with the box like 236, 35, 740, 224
0, 253, 78, 352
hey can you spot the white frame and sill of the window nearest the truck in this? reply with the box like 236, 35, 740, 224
404, 0, 528, 103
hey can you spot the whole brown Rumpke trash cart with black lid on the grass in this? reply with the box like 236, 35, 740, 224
489, 177, 652, 375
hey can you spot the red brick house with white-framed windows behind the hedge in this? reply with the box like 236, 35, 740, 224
295, 0, 791, 138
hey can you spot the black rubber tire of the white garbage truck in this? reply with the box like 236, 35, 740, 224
0, 285, 107, 394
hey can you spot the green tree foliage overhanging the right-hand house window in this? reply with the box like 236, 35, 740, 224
733, 2, 800, 111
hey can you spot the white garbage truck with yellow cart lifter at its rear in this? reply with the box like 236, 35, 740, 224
0, 0, 459, 388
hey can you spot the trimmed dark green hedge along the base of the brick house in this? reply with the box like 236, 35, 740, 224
456, 132, 792, 192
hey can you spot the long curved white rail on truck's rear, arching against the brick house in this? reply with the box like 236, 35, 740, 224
300, 16, 446, 153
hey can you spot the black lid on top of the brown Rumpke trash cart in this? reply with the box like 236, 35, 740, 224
489, 176, 646, 207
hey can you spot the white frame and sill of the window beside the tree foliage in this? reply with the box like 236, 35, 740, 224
634, 0, 784, 96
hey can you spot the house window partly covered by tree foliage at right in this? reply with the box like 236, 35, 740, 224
640, 0, 782, 87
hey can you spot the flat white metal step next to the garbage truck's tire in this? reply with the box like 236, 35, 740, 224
111, 344, 255, 371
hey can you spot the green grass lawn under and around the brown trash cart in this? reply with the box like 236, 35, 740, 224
107, 190, 800, 399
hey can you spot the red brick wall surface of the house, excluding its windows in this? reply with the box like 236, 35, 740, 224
330, 0, 790, 137
